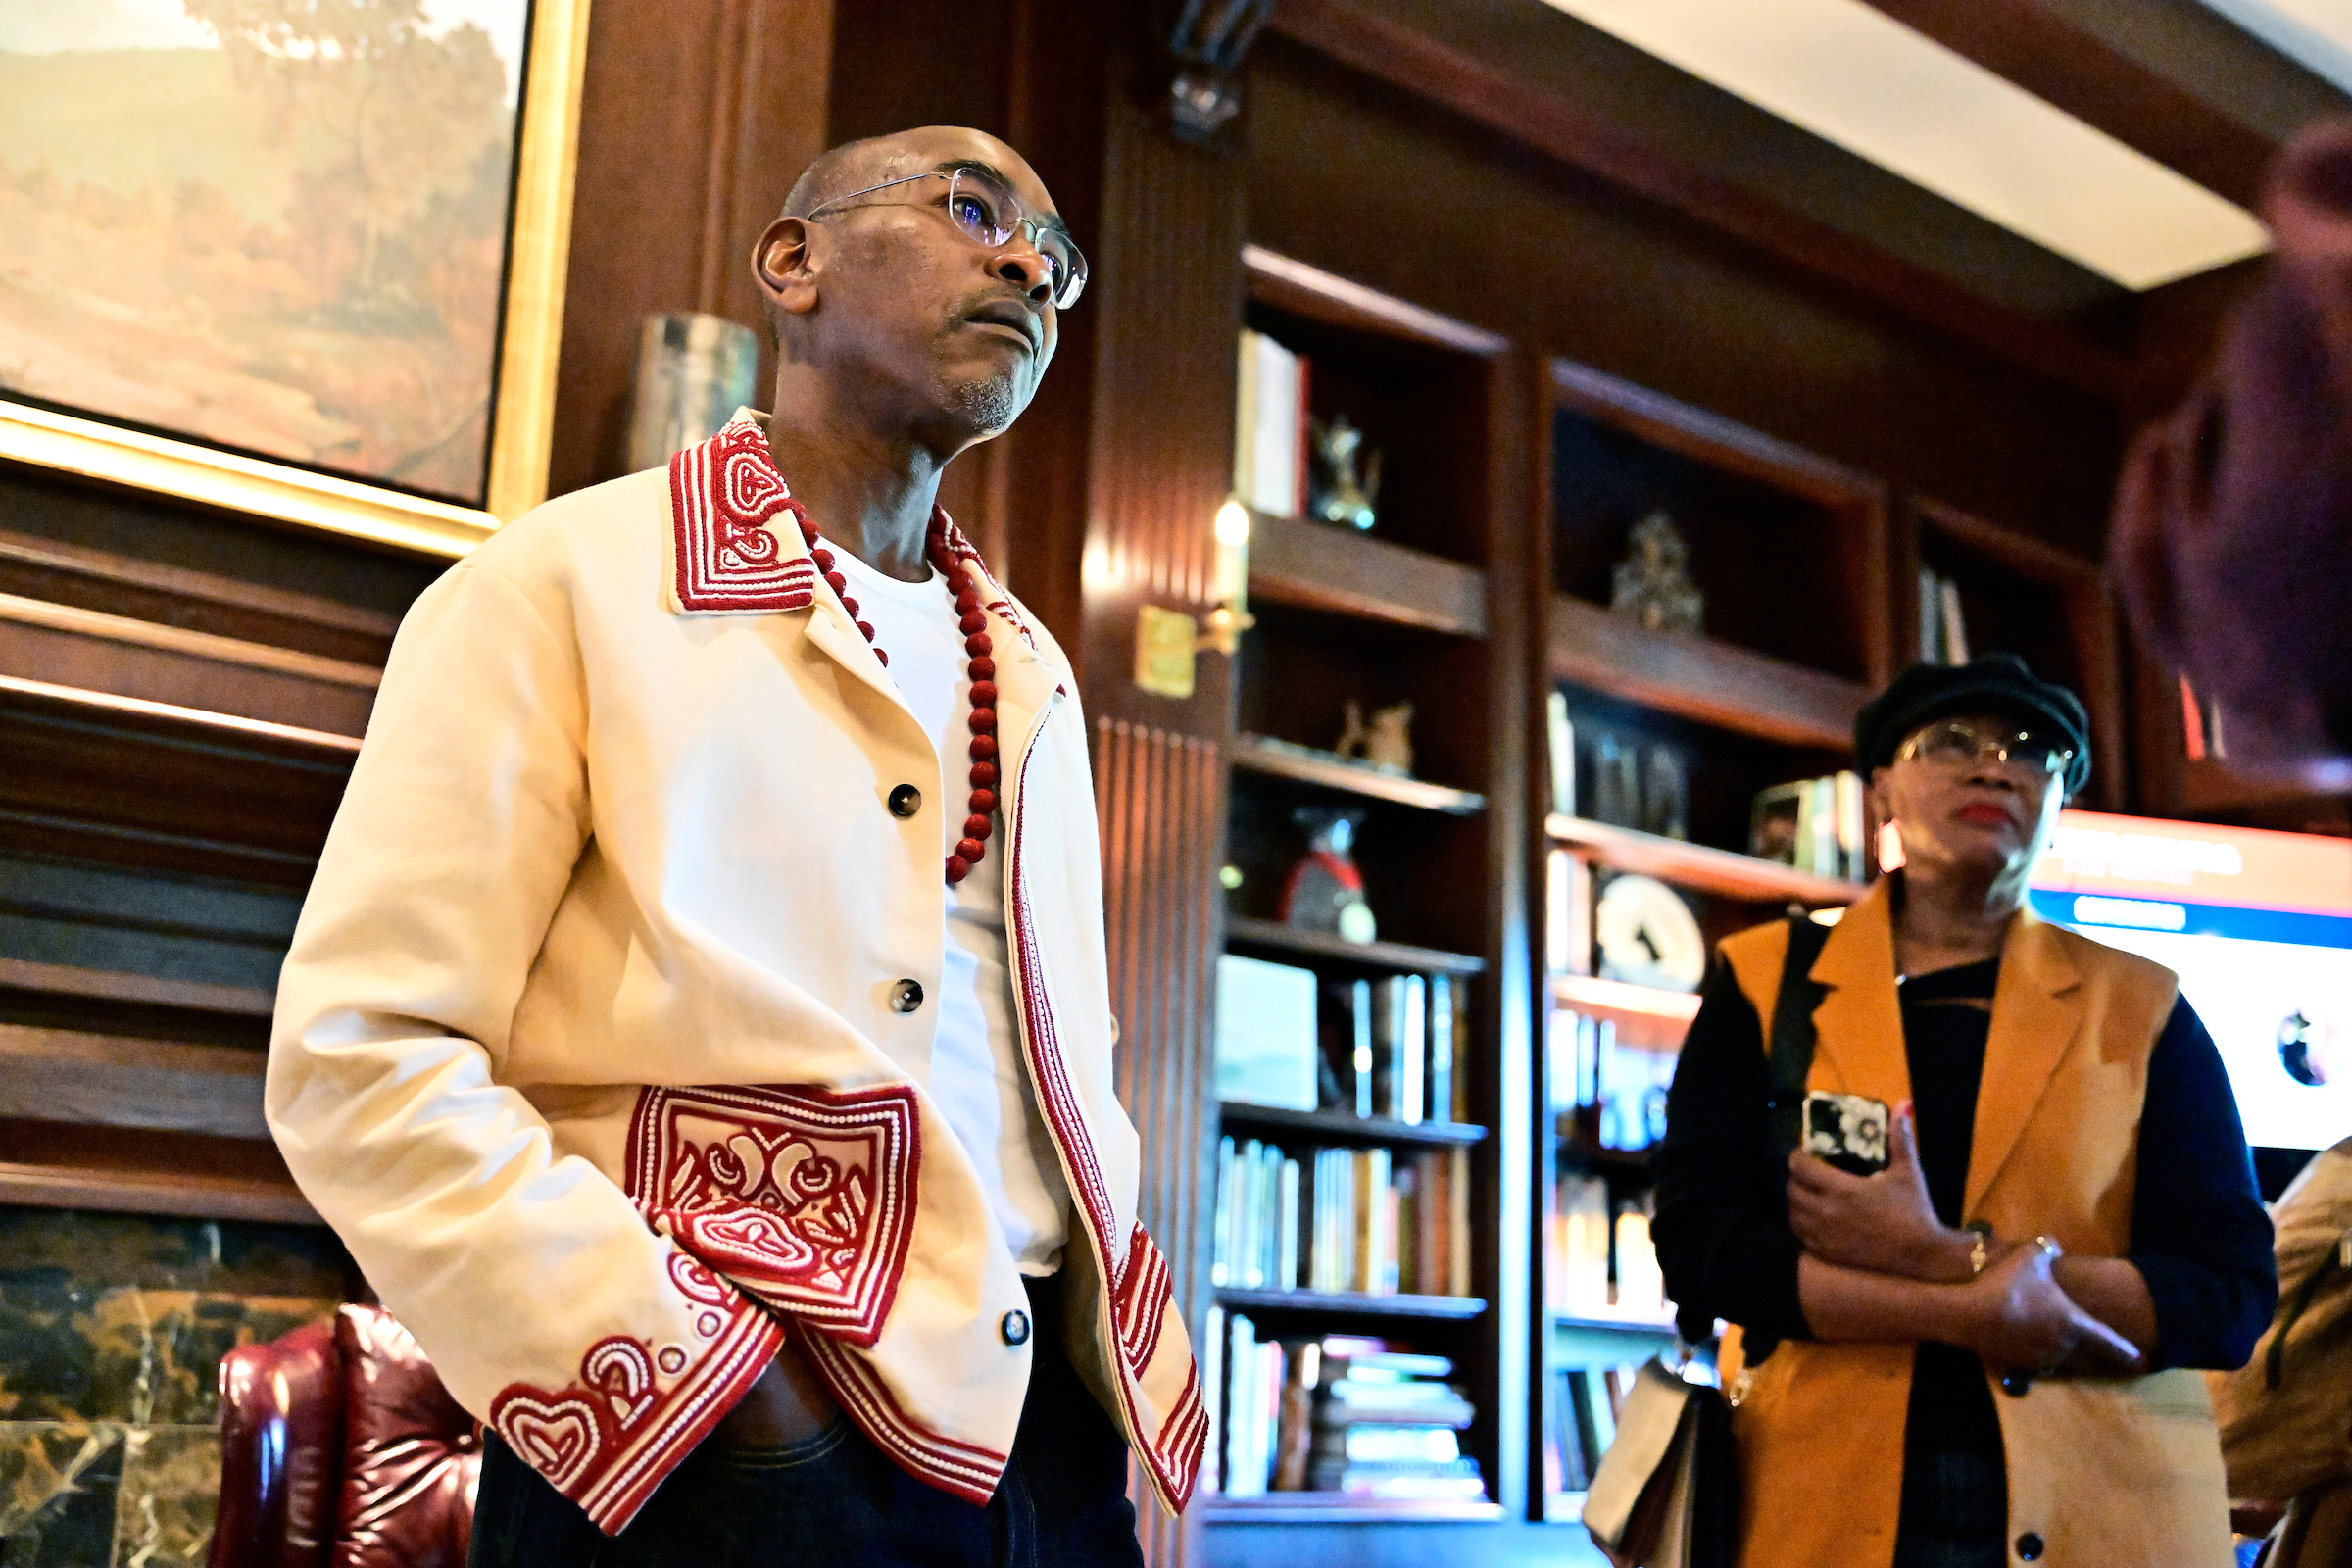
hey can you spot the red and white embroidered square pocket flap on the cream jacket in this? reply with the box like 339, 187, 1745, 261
625, 1084, 922, 1348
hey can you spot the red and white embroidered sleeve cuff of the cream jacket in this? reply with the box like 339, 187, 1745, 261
489, 1267, 783, 1535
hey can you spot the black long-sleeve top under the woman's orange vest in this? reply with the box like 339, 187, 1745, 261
1653, 959, 2279, 1410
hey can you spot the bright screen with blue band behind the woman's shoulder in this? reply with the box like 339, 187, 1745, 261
2033, 811, 2352, 1150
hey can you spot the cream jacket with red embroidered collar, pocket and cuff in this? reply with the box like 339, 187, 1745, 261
269, 416, 1206, 1533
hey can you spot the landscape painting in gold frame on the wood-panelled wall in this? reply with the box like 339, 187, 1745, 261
0, 0, 588, 555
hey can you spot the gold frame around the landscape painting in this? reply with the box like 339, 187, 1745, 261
0, 0, 590, 558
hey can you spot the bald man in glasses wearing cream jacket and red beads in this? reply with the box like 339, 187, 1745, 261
269, 127, 1206, 1566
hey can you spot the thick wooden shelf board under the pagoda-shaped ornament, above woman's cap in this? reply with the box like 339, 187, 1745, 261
1550, 595, 1870, 753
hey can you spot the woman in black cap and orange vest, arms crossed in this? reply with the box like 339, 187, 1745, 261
1656, 654, 2277, 1568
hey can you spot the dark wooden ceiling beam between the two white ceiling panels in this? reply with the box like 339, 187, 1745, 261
1868, 0, 2279, 212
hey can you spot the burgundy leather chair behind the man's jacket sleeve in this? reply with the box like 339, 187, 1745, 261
207, 1307, 482, 1568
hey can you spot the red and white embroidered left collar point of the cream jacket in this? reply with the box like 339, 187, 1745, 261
670, 418, 816, 615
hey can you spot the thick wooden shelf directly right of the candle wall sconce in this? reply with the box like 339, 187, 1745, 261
1249, 513, 1487, 637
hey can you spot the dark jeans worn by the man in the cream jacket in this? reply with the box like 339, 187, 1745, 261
466, 1277, 1143, 1568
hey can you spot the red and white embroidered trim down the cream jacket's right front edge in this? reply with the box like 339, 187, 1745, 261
1004, 748, 1209, 1514
